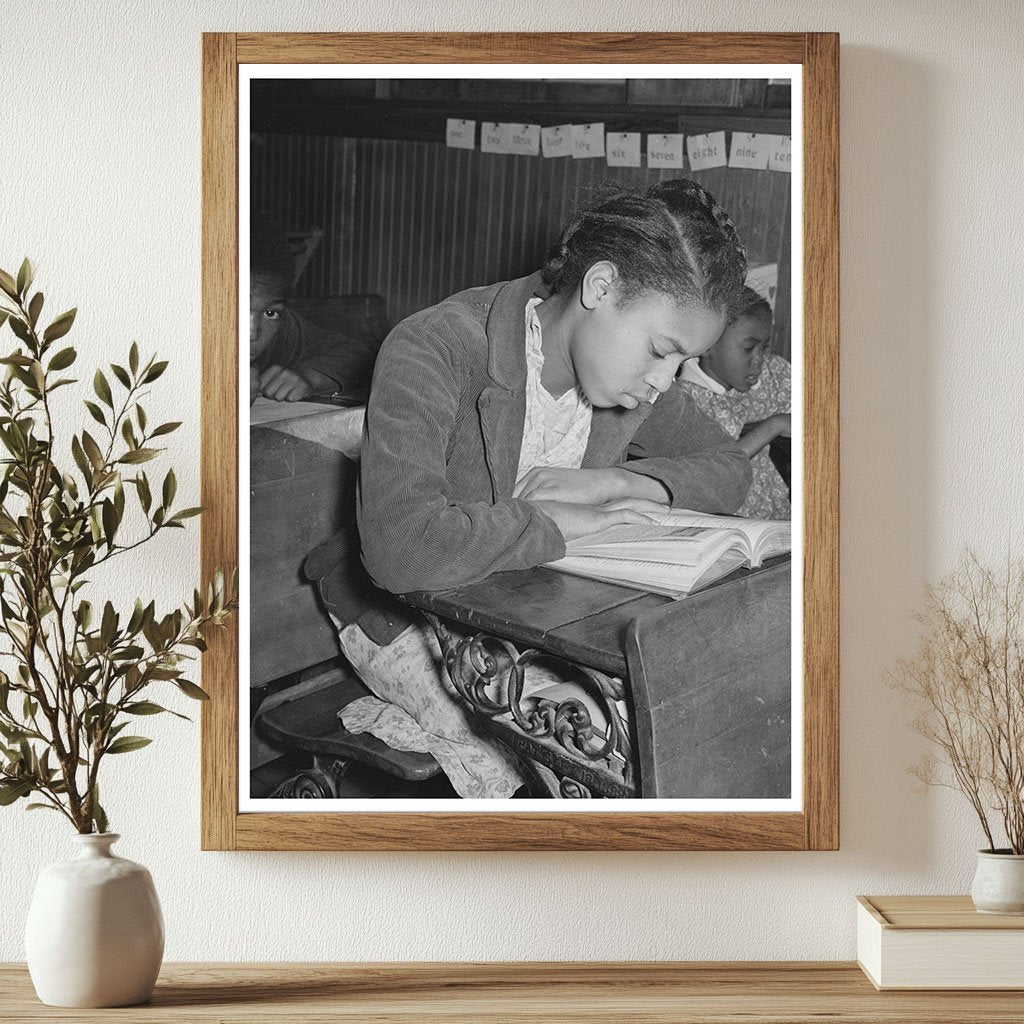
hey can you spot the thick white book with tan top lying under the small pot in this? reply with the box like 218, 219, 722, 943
857, 896, 1024, 991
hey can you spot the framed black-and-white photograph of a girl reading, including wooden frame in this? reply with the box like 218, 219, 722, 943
202, 33, 839, 850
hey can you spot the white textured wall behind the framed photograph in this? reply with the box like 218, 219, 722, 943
0, 0, 1024, 961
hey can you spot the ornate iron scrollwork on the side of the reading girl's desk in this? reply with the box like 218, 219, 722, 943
417, 612, 633, 798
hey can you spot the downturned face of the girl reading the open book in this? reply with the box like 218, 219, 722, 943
570, 284, 725, 409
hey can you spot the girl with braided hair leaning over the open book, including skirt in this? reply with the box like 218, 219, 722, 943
331, 179, 750, 797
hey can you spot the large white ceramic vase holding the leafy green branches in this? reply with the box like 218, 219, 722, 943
25, 833, 164, 1007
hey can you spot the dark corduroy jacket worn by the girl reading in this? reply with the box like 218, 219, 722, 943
356, 274, 751, 594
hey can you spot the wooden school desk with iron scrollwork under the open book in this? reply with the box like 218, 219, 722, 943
406, 556, 792, 799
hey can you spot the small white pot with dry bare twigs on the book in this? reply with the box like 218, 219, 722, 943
896, 554, 1024, 913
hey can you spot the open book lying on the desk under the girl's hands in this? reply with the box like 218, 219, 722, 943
547, 509, 792, 597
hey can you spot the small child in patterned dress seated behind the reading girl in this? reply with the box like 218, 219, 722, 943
679, 288, 792, 519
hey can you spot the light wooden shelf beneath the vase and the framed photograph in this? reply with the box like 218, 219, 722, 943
0, 963, 1024, 1024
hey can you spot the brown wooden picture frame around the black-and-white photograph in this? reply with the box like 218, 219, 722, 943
201, 33, 840, 850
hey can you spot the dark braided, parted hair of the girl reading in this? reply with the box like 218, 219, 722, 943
541, 178, 746, 317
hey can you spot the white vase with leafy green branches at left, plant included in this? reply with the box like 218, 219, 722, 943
0, 260, 237, 1007
